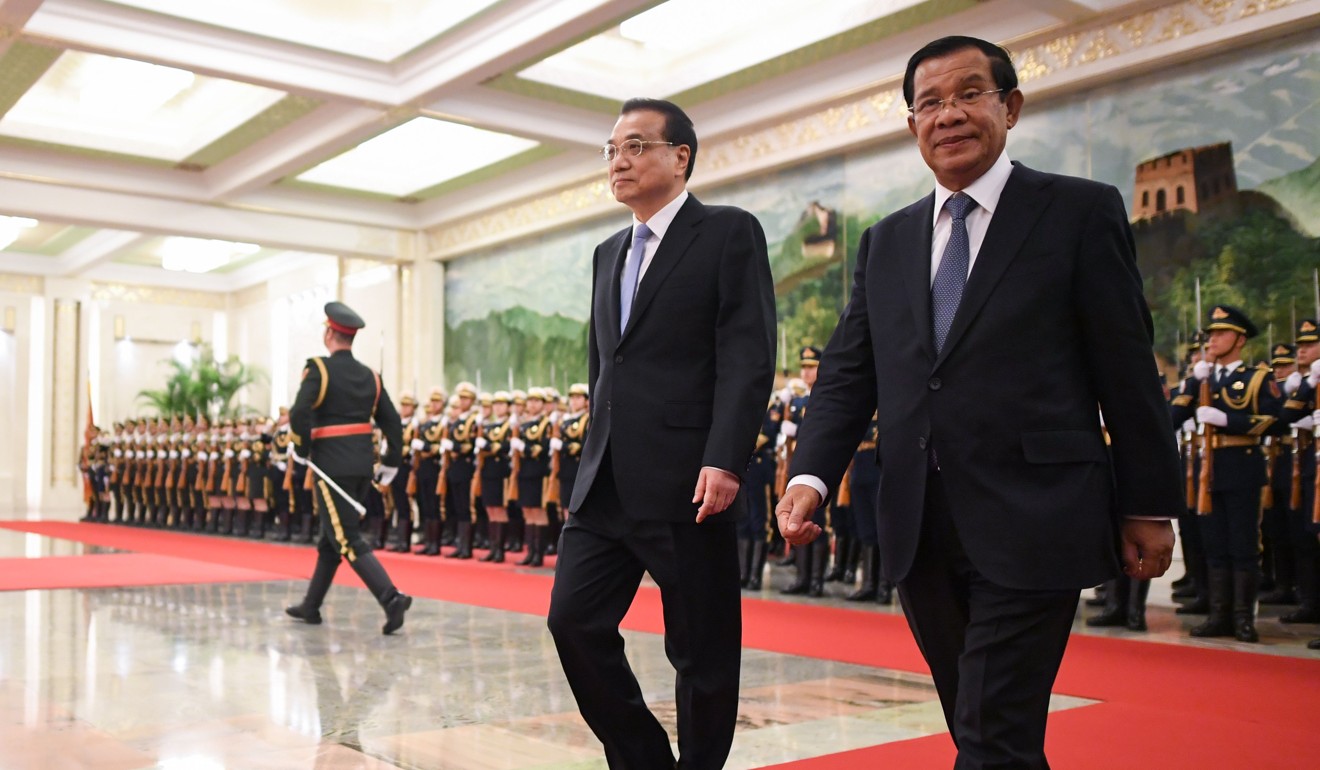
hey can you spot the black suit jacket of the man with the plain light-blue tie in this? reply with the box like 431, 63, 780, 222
569, 195, 775, 522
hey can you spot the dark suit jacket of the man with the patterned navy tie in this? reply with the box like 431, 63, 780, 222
792, 164, 1183, 589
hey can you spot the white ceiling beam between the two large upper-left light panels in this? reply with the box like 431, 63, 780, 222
24, 0, 399, 106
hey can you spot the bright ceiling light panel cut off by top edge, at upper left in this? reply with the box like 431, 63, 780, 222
105, 0, 499, 62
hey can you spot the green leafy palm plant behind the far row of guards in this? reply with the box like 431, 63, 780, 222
137, 345, 267, 420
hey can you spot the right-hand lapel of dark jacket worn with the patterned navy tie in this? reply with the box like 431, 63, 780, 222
935, 164, 1048, 366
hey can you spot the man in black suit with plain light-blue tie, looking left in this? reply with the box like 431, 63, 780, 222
549, 99, 775, 770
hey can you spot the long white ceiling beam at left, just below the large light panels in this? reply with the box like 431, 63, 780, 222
0, 178, 400, 259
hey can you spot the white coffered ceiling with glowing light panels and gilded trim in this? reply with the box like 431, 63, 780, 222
0, 0, 1320, 291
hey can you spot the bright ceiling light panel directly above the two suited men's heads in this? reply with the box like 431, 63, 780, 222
519, 0, 925, 100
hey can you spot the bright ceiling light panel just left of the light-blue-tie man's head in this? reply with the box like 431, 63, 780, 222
297, 118, 536, 195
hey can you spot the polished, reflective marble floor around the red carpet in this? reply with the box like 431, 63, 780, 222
0, 520, 1320, 770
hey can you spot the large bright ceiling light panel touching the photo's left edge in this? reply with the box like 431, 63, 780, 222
0, 50, 285, 162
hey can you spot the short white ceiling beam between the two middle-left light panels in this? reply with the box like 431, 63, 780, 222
203, 103, 399, 198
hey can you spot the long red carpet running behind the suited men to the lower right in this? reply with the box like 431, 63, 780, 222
0, 522, 1320, 770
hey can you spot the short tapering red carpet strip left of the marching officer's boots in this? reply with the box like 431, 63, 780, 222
0, 553, 285, 590
